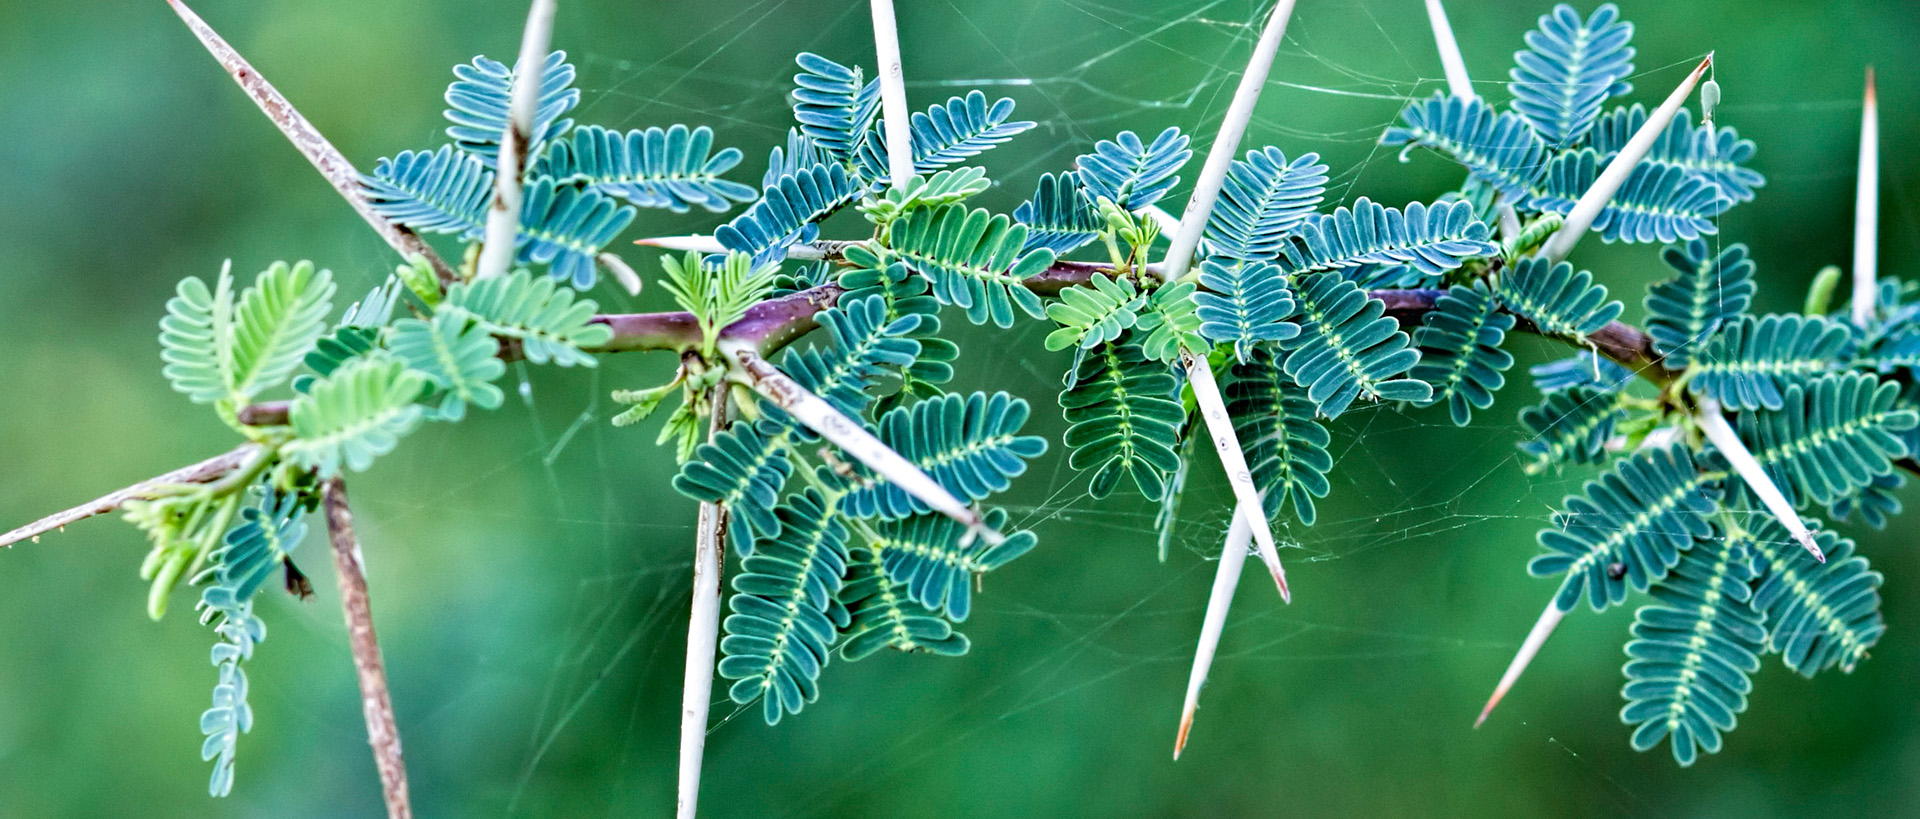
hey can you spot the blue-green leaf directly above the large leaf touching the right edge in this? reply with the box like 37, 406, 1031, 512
1688, 315, 1849, 409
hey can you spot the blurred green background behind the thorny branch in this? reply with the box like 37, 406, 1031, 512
0, 0, 1920, 817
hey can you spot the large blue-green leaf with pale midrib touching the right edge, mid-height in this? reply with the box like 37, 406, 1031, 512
1736, 372, 1920, 506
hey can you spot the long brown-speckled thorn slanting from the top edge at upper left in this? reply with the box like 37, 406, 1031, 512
167, 0, 457, 284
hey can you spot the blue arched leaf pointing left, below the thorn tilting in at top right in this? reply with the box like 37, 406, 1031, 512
1380, 94, 1549, 201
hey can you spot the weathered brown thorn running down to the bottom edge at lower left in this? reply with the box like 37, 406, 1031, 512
321, 478, 413, 819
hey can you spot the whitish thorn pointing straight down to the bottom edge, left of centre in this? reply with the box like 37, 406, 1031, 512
676, 384, 728, 819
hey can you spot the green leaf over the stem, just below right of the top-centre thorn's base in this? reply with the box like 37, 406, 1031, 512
893, 205, 1054, 328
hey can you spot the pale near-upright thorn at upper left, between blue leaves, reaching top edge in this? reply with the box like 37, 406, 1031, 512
474, 0, 555, 278
